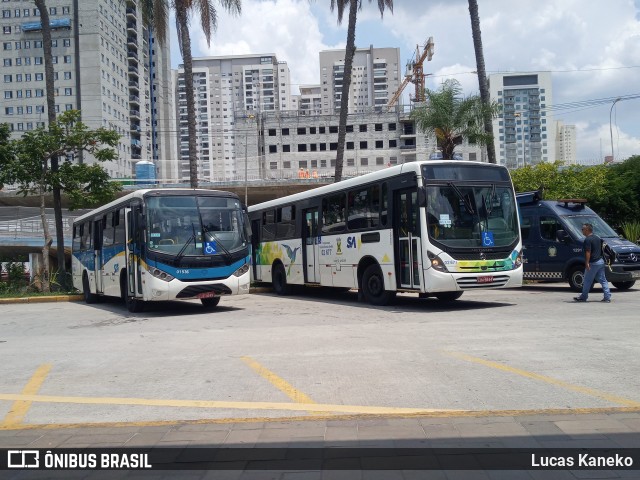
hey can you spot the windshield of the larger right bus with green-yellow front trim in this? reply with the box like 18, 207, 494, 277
426, 182, 518, 248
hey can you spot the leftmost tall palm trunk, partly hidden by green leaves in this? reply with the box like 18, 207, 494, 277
34, 0, 69, 290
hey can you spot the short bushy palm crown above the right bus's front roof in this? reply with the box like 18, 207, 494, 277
411, 79, 499, 160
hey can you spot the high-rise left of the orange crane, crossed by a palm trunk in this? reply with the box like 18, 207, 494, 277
320, 45, 400, 114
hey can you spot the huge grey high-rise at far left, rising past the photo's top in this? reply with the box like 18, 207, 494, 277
0, 0, 175, 178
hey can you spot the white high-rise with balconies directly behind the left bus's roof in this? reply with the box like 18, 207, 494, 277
173, 54, 293, 181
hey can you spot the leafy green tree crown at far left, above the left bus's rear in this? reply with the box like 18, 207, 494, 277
0, 110, 121, 208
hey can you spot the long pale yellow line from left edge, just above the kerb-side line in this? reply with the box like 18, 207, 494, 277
0, 393, 447, 415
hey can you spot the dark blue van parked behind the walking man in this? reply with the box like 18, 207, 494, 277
516, 192, 640, 292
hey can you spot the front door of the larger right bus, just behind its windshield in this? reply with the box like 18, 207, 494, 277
395, 189, 422, 289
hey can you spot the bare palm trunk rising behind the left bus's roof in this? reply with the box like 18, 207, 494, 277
175, 8, 198, 188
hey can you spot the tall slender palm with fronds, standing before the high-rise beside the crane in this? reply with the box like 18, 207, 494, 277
331, 0, 393, 182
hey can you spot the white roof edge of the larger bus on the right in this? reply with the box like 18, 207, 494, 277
249, 160, 505, 212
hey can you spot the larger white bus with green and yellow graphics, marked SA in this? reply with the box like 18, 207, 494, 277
249, 161, 522, 305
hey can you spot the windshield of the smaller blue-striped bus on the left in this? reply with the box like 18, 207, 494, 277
147, 195, 248, 257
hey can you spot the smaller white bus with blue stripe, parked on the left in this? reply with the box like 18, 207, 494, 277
72, 189, 251, 312
